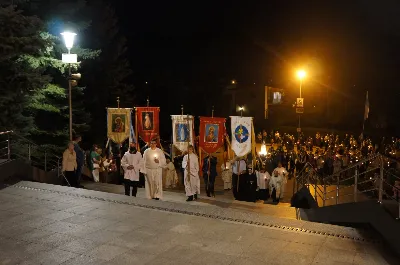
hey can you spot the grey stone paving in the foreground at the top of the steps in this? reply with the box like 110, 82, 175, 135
0, 182, 399, 265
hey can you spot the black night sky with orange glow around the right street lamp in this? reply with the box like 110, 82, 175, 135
112, 0, 400, 134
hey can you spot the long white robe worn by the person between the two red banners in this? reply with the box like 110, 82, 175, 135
182, 154, 200, 196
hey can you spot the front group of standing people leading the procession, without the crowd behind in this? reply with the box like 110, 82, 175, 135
62, 136, 290, 201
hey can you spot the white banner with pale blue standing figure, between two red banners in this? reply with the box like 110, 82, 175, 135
171, 115, 194, 152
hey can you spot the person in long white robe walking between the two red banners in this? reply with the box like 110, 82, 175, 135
182, 145, 200, 201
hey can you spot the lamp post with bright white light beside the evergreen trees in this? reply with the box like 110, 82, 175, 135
61, 32, 77, 141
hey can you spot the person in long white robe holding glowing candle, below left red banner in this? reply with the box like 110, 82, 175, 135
142, 139, 167, 200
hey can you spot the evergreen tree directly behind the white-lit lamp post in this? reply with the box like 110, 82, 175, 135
17, 0, 100, 152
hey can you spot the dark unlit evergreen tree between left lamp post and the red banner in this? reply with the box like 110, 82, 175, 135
82, 0, 135, 142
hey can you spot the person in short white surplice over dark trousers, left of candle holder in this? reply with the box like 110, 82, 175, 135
121, 143, 143, 197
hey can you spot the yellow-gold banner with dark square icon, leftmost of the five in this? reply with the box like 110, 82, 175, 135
107, 108, 132, 144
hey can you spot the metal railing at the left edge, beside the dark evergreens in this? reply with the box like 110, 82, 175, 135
0, 131, 63, 180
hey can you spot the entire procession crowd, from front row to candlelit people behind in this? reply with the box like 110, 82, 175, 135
63, 130, 400, 202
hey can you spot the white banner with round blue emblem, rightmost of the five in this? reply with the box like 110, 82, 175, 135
231, 116, 253, 156
